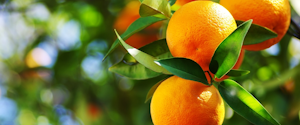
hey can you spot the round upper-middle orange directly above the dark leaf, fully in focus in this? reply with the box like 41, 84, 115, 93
166, 1, 237, 82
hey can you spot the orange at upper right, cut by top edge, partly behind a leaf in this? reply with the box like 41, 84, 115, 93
220, 0, 291, 51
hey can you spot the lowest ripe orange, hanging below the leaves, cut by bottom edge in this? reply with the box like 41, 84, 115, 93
150, 76, 225, 125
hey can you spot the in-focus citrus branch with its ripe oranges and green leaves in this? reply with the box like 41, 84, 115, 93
104, 0, 299, 125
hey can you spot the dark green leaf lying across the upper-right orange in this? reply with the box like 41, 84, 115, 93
236, 20, 277, 45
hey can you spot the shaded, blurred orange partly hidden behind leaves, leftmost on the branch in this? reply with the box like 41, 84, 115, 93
114, 1, 161, 48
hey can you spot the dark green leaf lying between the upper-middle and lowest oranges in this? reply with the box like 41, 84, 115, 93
156, 58, 209, 85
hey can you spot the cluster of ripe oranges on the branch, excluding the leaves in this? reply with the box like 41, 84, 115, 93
115, 0, 291, 125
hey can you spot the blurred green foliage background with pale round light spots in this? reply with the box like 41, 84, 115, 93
0, 0, 300, 125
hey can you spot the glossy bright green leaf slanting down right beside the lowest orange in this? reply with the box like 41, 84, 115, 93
218, 79, 280, 125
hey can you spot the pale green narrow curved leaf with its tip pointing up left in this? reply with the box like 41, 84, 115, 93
115, 30, 171, 74
